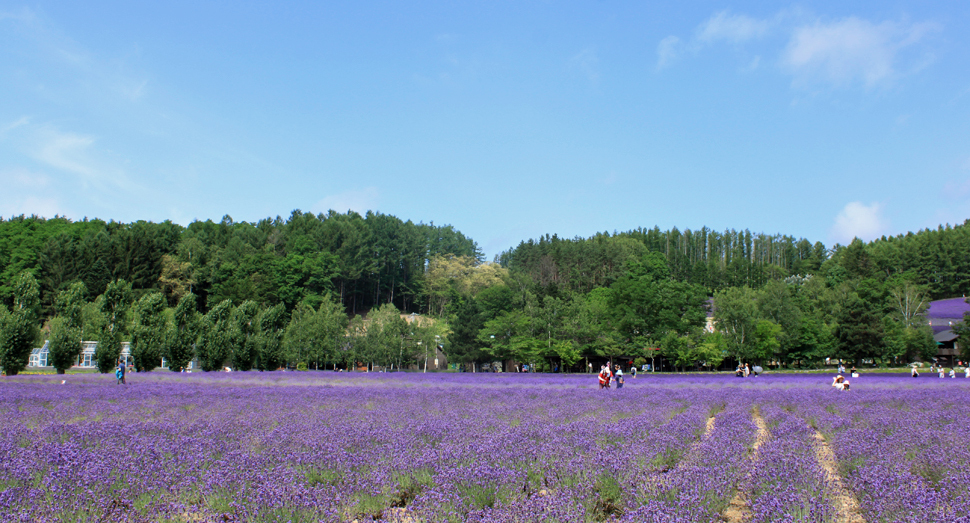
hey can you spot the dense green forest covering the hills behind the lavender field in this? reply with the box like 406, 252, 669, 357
0, 211, 970, 375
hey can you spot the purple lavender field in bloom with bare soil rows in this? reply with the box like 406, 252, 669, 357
0, 372, 970, 522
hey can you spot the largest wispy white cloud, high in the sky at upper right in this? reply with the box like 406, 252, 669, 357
782, 17, 936, 87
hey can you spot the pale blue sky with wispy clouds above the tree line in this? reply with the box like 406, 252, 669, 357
0, 0, 970, 258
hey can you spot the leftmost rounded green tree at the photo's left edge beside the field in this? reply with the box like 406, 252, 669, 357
0, 271, 40, 376
